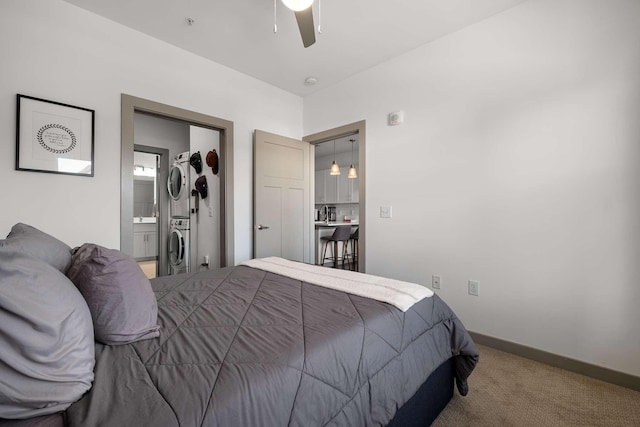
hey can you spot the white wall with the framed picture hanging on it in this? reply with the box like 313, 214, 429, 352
0, 0, 302, 262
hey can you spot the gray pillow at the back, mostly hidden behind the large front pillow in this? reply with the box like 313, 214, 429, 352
0, 223, 71, 273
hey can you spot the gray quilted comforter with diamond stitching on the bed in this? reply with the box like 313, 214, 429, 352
67, 266, 478, 427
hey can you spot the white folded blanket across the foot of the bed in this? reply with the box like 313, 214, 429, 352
241, 257, 433, 311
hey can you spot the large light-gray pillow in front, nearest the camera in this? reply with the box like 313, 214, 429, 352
0, 248, 95, 419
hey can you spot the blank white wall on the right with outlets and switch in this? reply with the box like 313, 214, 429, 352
304, 0, 640, 375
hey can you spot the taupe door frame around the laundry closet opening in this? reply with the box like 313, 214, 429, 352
120, 93, 235, 267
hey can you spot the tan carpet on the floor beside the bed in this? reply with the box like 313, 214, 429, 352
432, 346, 640, 427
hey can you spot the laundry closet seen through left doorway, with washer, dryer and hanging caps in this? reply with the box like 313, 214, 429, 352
133, 113, 223, 277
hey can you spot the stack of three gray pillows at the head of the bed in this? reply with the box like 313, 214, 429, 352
0, 224, 159, 419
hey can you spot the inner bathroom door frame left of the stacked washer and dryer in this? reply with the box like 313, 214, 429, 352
133, 144, 169, 277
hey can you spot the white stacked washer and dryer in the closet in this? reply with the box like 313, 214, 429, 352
167, 151, 191, 274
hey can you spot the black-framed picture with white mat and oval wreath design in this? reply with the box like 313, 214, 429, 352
16, 94, 95, 176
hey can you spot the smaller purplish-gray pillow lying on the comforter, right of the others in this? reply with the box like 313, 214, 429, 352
67, 243, 160, 345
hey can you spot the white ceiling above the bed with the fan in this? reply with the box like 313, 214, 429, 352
65, 0, 525, 96
